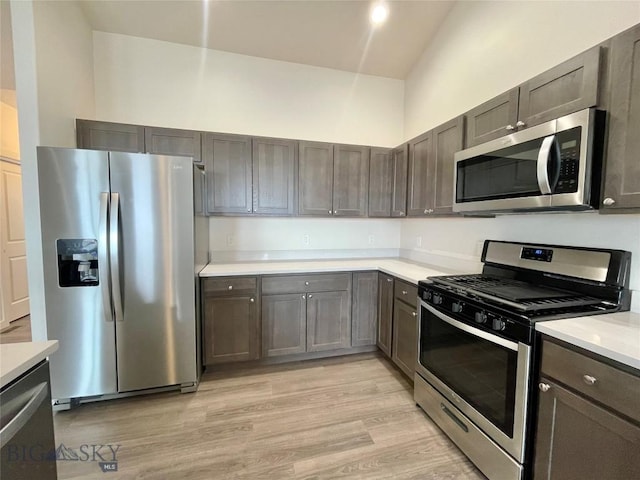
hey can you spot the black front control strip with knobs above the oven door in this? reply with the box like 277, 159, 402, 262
418, 285, 534, 344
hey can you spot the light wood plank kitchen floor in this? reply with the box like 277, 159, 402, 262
54, 353, 485, 480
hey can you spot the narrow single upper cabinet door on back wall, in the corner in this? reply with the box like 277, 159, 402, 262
369, 148, 393, 217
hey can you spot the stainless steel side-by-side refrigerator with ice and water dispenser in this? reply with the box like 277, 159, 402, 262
38, 147, 208, 406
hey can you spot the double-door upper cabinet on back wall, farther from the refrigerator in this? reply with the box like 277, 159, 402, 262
298, 142, 369, 217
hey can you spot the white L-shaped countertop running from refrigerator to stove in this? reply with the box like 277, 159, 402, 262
200, 258, 462, 285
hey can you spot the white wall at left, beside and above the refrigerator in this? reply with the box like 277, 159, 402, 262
11, 1, 94, 340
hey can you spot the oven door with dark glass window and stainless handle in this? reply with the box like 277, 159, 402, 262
416, 301, 531, 463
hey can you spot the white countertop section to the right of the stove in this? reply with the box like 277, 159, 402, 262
536, 312, 640, 369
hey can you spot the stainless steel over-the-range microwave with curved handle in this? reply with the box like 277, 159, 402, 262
453, 108, 605, 213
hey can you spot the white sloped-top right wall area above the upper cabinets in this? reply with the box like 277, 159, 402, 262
404, 1, 640, 139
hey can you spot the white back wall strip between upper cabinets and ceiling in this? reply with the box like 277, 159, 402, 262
93, 32, 404, 147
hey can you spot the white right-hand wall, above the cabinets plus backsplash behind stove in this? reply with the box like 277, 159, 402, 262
401, 1, 640, 311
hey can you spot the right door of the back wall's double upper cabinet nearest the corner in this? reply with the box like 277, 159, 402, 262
333, 145, 369, 217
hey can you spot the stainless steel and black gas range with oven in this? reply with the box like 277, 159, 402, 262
414, 240, 631, 480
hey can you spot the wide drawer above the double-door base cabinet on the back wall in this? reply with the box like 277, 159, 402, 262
262, 273, 351, 295
